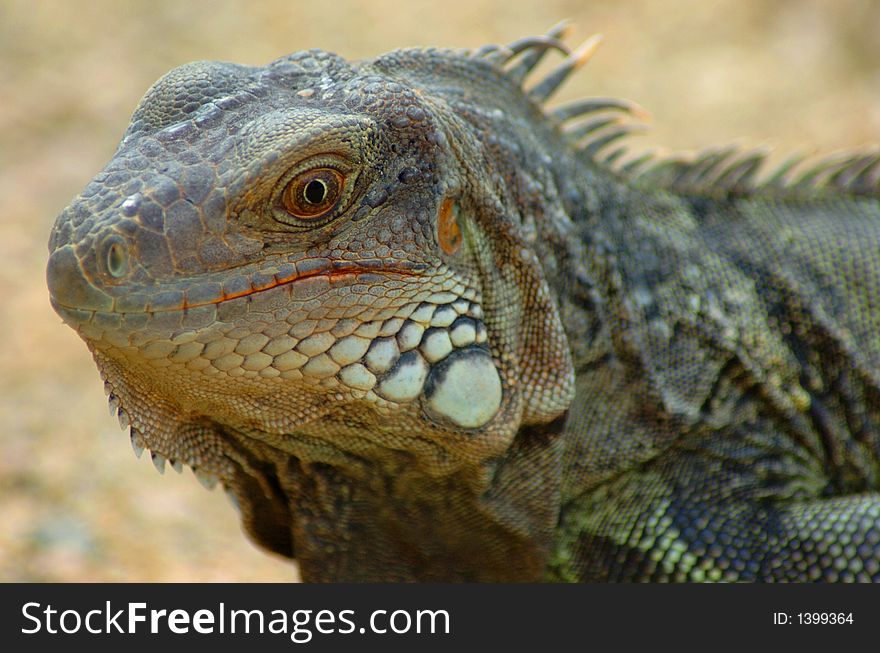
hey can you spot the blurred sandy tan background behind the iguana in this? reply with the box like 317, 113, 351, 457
0, 0, 880, 581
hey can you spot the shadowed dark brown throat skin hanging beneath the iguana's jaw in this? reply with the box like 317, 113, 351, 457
217, 418, 564, 581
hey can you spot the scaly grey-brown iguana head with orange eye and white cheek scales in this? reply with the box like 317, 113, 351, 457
48, 40, 573, 479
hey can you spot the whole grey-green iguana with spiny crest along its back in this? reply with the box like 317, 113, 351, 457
47, 26, 880, 581
